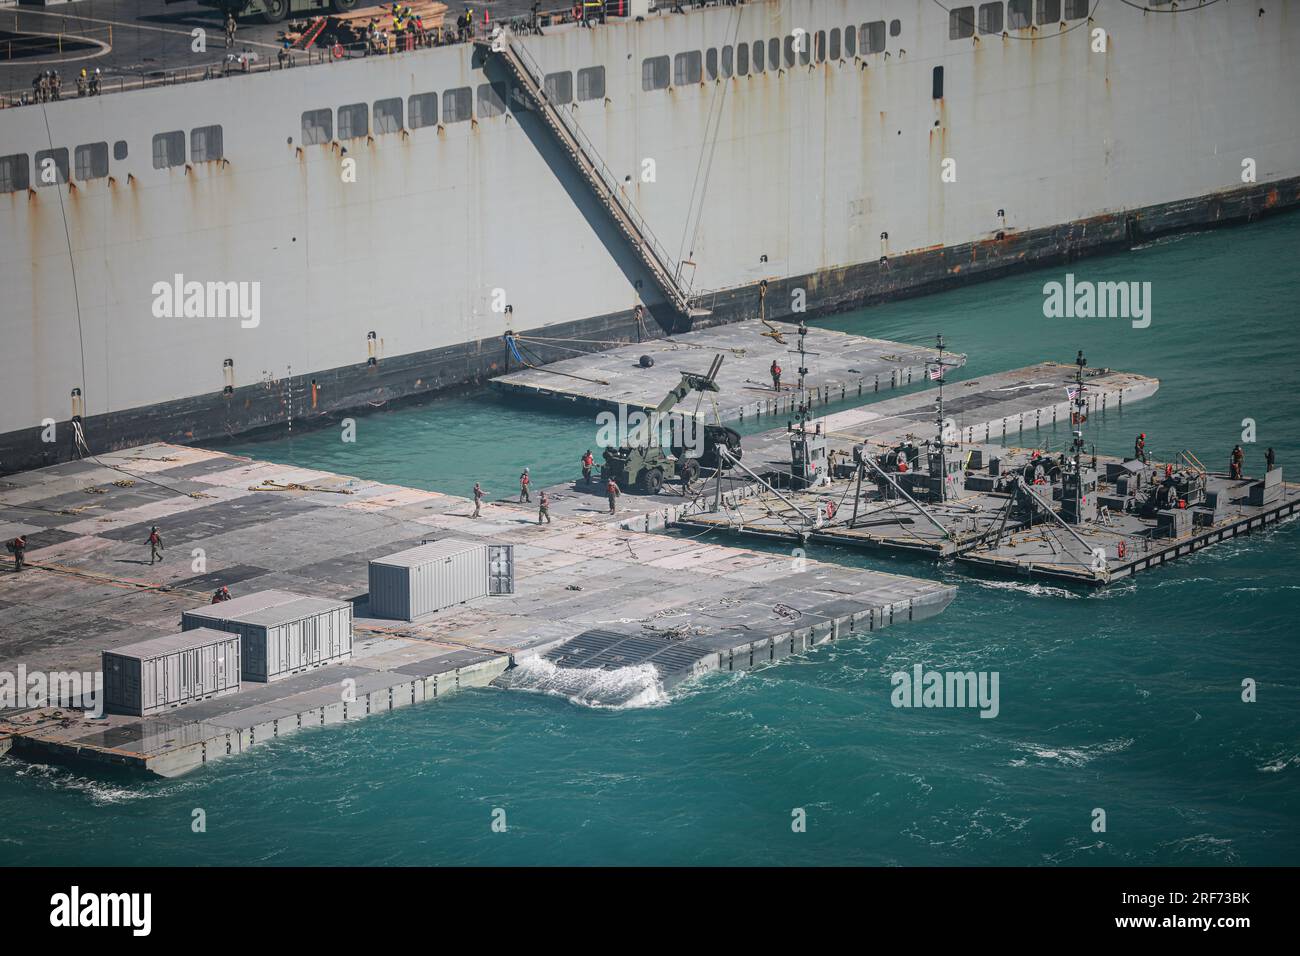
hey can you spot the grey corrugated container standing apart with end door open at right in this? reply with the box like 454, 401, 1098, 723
371, 538, 488, 620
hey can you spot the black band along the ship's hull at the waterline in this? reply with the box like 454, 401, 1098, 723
0, 178, 1300, 475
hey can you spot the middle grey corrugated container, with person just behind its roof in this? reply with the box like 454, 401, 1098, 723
181, 591, 352, 682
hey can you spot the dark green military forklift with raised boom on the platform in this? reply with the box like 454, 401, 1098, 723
601, 355, 741, 494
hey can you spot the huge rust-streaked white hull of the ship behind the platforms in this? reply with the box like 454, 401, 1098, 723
0, 0, 1300, 471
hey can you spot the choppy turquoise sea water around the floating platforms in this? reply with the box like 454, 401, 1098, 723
0, 216, 1300, 865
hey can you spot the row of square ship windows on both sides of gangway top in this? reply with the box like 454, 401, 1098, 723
302, 66, 605, 146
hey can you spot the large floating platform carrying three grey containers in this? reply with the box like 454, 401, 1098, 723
0, 445, 954, 775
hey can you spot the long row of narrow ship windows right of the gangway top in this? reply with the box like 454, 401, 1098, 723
641, 20, 902, 91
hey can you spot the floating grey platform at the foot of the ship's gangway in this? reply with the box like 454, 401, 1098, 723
491, 320, 965, 421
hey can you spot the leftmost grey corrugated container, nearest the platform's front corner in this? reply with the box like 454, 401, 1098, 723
103, 627, 241, 717
